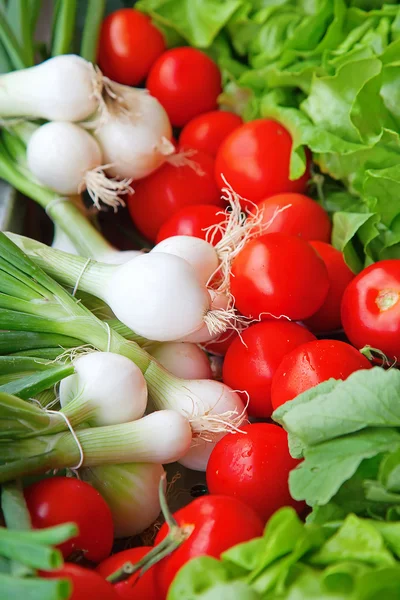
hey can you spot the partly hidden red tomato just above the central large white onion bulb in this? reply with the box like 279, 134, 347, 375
156, 204, 226, 246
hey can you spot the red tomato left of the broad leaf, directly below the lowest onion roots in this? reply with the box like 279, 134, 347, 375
206, 423, 304, 522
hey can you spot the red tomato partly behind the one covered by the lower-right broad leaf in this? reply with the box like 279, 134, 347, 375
222, 321, 315, 417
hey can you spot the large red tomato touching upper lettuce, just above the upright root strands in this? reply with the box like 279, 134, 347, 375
215, 119, 309, 203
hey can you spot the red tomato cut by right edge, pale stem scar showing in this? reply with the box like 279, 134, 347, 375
342, 259, 400, 360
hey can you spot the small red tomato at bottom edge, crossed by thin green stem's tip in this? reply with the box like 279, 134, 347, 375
96, 546, 158, 600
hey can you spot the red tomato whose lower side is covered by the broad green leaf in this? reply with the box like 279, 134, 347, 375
271, 340, 372, 410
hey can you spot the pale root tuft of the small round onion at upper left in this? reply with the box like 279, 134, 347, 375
79, 165, 133, 212
